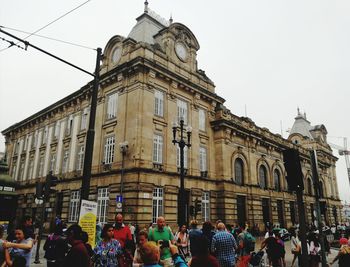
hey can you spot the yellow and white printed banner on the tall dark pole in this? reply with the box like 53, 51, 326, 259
79, 199, 97, 248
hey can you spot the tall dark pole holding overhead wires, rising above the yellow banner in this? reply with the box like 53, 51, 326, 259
81, 48, 102, 200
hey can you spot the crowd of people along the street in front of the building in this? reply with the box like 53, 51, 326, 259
0, 214, 350, 267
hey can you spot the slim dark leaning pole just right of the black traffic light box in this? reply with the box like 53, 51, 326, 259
310, 150, 327, 267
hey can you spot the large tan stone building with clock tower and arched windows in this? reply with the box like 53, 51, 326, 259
2, 4, 341, 228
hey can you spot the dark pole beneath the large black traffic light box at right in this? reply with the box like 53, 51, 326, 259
296, 188, 308, 267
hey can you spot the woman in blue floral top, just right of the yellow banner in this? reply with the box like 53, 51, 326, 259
93, 224, 122, 267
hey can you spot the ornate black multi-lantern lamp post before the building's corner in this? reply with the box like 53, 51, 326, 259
173, 117, 192, 226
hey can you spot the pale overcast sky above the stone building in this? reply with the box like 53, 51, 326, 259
0, 0, 350, 201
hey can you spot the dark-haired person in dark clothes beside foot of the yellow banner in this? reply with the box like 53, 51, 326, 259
62, 224, 91, 267
